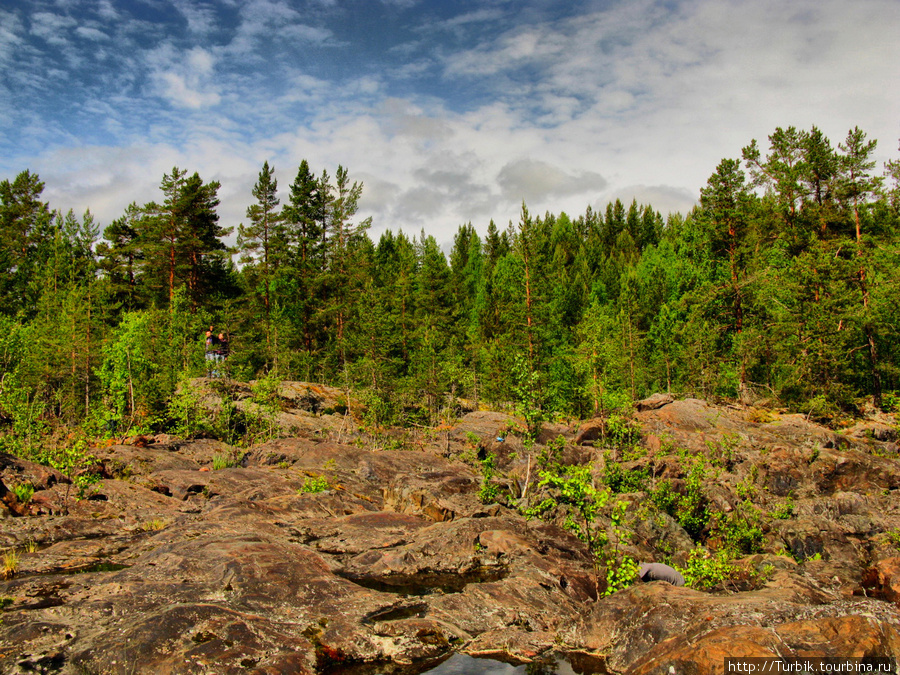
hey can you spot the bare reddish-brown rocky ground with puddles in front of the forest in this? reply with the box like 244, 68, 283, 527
0, 383, 900, 674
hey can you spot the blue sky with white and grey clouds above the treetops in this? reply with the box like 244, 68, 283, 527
0, 0, 900, 245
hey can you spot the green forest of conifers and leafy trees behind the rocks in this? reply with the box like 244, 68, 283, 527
0, 127, 900, 454
